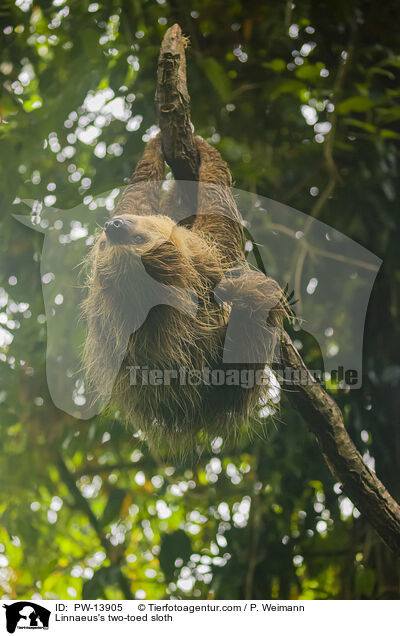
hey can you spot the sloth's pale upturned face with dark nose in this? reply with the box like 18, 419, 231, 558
97, 214, 176, 260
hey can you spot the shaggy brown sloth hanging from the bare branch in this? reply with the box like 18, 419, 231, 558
83, 136, 284, 452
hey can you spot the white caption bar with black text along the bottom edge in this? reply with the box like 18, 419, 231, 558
0, 600, 394, 636
